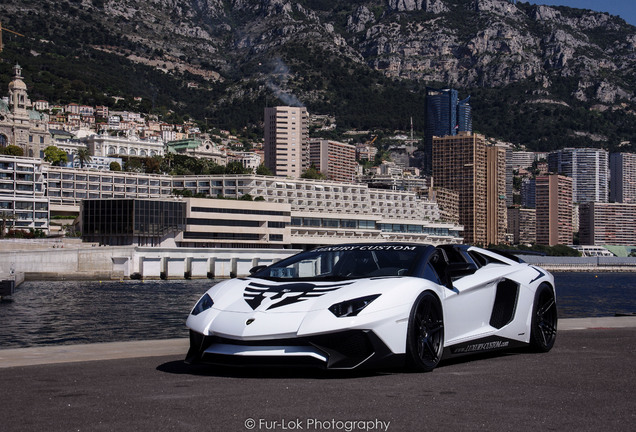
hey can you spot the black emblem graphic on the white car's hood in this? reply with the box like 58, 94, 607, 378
243, 282, 353, 310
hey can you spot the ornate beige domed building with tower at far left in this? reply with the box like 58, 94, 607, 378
0, 64, 51, 158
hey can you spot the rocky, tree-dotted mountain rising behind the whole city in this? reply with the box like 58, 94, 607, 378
0, 0, 636, 151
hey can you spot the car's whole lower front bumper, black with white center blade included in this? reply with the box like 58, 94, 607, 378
186, 330, 404, 369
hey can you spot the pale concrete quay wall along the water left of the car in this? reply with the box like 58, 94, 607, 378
0, 246, 299, 280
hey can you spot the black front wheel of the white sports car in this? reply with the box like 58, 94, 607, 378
406, 291, 444, 372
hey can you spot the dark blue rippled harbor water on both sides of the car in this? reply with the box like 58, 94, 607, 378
0, 273, 636, 349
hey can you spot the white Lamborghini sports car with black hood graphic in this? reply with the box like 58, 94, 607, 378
186, 243, 557, 371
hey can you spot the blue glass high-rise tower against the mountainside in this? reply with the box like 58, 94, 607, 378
424, 88, 473, 172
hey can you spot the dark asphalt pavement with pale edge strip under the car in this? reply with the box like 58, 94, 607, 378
0, 317, 636, 432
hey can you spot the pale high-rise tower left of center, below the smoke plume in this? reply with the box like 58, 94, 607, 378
264, 106, 309, 178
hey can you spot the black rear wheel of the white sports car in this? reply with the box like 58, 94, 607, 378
530, 283, 558, 352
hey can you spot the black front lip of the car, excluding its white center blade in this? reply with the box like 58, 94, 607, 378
185, 330, 404, 369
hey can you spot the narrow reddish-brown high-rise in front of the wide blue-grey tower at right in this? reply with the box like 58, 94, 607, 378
536, 174, 573, 246
